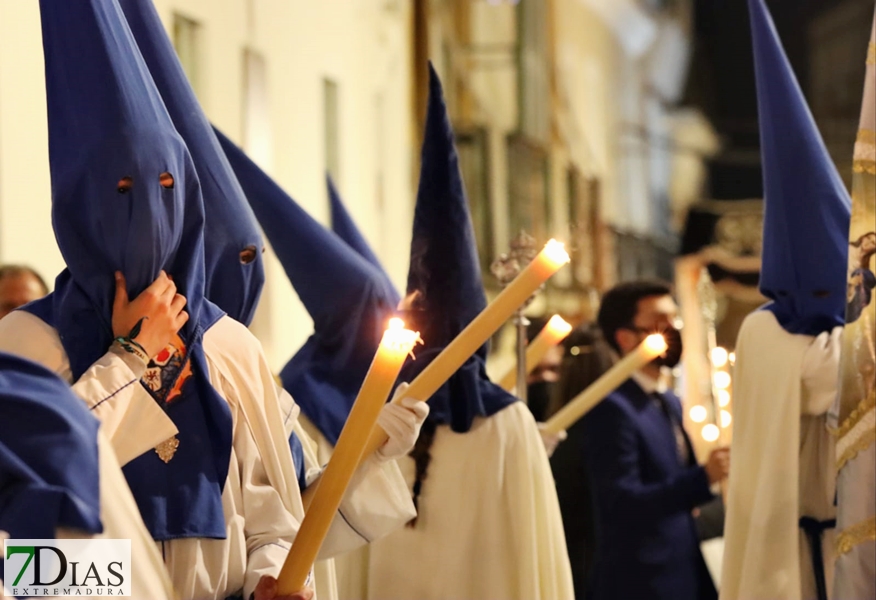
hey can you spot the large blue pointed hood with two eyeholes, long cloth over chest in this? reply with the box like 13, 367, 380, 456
26, 0, 231, 540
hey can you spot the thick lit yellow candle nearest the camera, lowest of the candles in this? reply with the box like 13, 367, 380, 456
277, 319, 420, 595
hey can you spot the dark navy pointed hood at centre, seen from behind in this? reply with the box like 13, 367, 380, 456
400, 64, 516, 433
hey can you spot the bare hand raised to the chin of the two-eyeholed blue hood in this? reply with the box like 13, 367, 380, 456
113, 271, 189, 358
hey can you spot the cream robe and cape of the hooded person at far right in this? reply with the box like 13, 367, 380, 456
720, 310, 836, 600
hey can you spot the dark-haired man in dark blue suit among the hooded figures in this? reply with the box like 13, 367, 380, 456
583, 281, 729, 600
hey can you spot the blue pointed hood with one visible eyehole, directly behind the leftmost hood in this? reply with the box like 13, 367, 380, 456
121, 0, 265, 325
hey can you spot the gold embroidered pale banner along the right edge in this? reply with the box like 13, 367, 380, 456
831, 10, 876, 598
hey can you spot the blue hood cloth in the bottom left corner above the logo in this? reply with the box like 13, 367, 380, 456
0, 353, 103, 544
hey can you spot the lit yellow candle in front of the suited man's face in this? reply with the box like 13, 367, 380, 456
544, 333, 667, 433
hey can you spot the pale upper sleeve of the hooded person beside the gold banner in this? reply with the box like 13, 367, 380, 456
801, 327, 843, 415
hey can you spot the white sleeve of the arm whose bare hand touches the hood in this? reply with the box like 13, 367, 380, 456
0, 310, 177, 465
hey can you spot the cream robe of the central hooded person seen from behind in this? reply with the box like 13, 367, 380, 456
362, 402, 574, 600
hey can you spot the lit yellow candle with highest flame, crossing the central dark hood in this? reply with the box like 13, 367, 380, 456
363, 240, 569, 456
